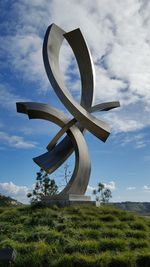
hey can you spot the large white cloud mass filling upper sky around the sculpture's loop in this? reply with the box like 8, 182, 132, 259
0, 0, 150, 133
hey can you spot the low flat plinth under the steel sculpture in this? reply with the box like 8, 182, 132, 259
42, 194, 96, 207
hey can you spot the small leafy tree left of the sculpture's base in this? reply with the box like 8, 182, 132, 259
27, 169, 58, 203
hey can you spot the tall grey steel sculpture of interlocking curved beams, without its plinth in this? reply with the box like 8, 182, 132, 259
17, 24, 120, 199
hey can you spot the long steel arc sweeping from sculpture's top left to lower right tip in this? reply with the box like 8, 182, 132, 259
43, 24, 110, 142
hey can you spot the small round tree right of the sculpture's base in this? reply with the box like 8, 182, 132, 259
93, 183, 112, 204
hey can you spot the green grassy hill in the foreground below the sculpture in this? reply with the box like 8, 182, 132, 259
0, 206, 150, 267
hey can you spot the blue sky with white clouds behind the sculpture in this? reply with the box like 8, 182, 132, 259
0, 0, 150, 203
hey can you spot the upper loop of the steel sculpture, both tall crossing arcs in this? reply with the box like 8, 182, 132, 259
43, 24, 110, 141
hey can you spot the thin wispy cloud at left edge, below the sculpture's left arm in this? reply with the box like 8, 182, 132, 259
0, 132, 37, 148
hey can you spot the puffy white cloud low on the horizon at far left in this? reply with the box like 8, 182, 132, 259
0, 182, 29, 203
